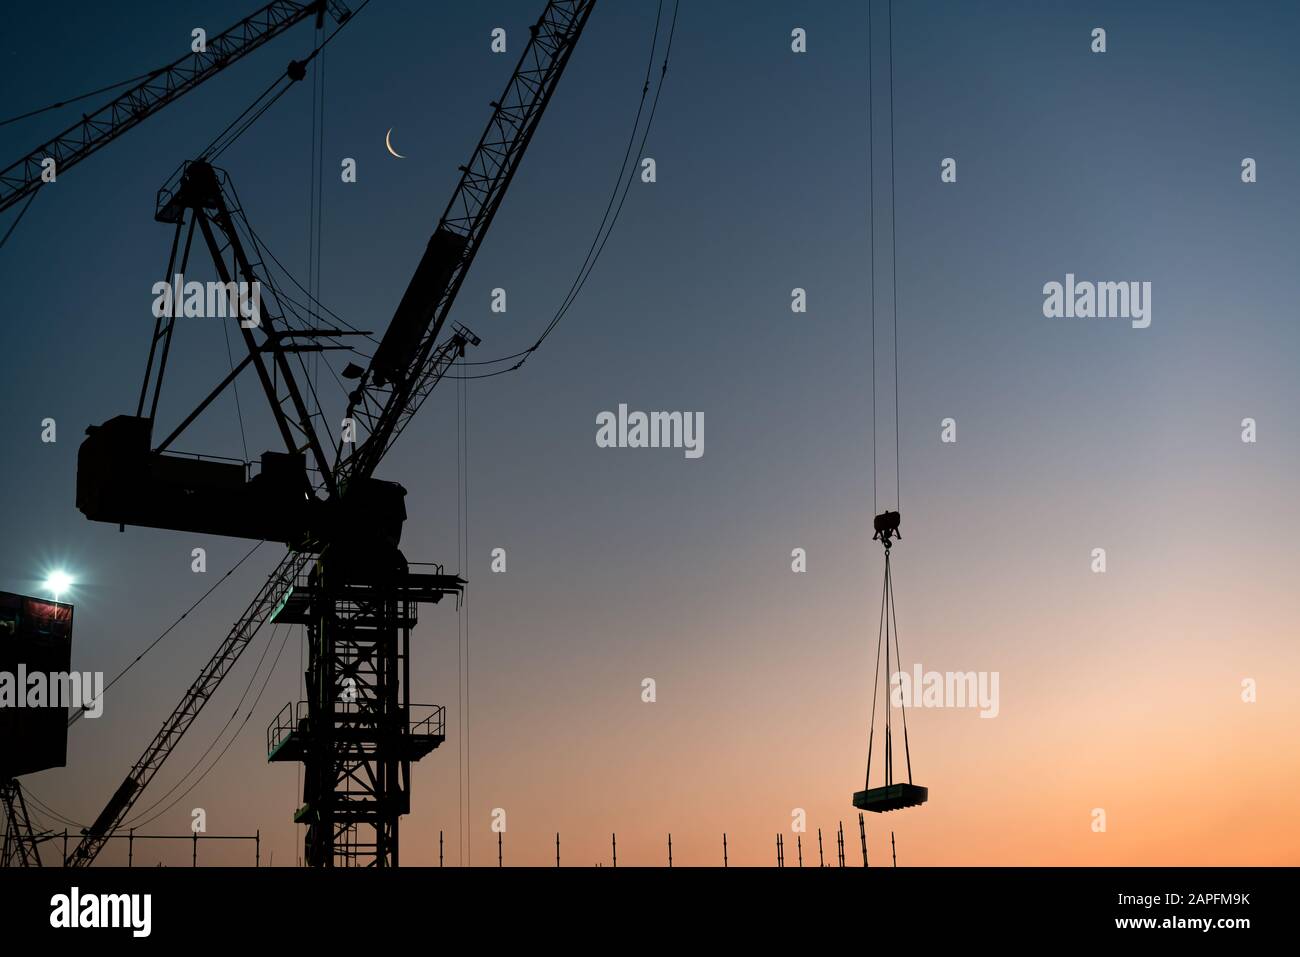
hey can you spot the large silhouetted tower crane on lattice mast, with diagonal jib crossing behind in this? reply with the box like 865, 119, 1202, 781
66, 0, 595, 866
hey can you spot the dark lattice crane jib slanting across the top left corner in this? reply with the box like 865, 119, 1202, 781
0, 0, 351, 212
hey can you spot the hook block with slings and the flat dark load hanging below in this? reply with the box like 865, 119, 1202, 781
853, 511, 930, 813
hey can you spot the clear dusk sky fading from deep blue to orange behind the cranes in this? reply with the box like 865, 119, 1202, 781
0, 0, 1300, 866
